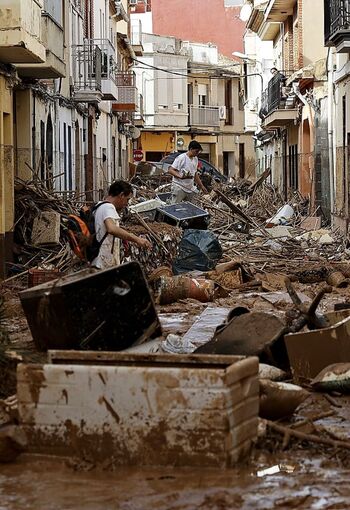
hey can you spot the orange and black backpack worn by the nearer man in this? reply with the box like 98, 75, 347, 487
67, 202, 109, 262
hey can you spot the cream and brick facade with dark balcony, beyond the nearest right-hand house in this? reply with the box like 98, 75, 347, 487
245, 0, 331, 219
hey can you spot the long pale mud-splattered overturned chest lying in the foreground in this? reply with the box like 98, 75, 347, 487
18, 351, 259, 467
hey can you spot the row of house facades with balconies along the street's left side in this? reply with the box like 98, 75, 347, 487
0, 0, 141, 277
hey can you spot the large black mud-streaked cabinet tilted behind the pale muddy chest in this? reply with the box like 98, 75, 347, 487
20, 262, 161, 351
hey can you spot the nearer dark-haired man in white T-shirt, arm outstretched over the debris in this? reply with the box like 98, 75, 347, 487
92, 181, 152, 269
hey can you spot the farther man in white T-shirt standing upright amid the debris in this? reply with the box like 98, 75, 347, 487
168, 140, 208, 204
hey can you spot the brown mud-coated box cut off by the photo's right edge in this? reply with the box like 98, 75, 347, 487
284, 310, 350, 380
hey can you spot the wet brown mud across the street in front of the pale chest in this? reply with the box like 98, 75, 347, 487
0, 448, 350, 510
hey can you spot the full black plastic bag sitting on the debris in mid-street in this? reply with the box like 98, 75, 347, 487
173, 229, 222, 274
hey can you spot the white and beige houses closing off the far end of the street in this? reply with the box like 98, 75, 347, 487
132, 26, 255, 177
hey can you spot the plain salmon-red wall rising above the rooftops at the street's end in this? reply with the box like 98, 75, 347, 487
152, 0, 245, 57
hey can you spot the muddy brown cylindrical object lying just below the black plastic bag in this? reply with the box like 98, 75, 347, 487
158, 276, 215, 305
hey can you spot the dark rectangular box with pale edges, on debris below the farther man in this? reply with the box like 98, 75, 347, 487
156, 202, 210, 230
